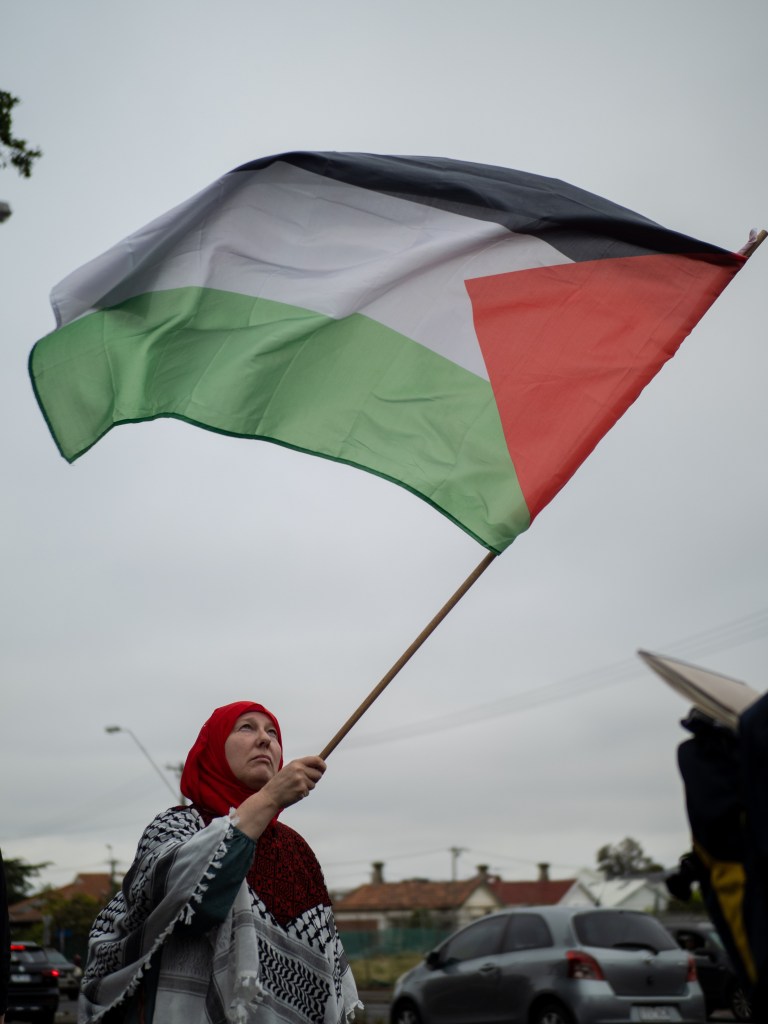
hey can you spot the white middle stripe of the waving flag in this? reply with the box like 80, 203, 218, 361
51, 162, 571, 379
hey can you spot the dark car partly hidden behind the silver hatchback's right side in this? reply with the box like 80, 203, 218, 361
664, 919, 752, 1021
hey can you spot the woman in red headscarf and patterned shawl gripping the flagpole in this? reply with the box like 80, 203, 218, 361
79, 701, 360, 1024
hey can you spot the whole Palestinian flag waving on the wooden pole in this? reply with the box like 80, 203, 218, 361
30, 153, 744, 552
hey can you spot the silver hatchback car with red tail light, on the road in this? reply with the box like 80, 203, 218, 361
390, 906, 706, 1024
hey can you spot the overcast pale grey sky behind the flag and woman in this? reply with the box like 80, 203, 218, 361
0, 0, 768, 888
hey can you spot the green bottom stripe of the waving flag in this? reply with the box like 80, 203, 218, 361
30, 288, 529, 551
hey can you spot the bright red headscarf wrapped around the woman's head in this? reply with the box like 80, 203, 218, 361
181, 700, 283, 815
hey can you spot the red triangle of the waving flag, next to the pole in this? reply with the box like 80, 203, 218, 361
466, 248, 743, 520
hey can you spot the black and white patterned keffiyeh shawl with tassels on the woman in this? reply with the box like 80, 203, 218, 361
79, 807, 361, 1024
